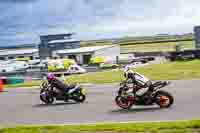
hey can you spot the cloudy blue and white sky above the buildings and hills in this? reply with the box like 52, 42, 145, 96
0, 0, 200, 46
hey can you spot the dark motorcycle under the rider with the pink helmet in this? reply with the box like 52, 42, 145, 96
40, 82, 86, 104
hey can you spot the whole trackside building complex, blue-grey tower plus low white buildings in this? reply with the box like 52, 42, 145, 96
0, 33, 120, 65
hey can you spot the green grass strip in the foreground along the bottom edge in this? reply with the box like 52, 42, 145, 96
0, 120, 200, 133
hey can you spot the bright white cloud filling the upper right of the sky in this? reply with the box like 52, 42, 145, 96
88, 0, 200, 35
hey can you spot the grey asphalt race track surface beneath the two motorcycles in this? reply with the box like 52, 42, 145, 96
0, 80, 200, 125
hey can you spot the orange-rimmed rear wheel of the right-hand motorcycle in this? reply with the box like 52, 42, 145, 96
155, 91, 174, 108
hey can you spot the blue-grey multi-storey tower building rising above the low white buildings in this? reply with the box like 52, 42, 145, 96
39, 33, 80, 59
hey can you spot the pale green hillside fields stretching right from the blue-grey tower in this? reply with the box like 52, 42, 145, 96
81, 35, 195, 53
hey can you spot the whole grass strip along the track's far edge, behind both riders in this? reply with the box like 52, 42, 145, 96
5, 60, 200, 88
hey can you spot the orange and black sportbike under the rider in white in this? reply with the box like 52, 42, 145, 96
115, 81, 174, 109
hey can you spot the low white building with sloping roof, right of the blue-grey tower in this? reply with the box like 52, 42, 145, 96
53, 45, 120, 64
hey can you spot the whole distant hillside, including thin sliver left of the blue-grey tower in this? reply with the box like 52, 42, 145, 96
0, 33, 195, 53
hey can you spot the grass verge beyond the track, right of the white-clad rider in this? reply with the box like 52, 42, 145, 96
136, 60, 200, 80
